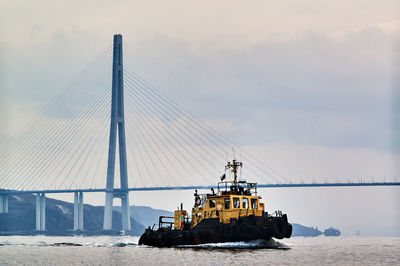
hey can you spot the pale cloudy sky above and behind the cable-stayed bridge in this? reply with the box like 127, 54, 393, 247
0, 0, 400, 235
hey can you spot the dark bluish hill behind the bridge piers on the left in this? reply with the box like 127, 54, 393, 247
0, 194, 145, 235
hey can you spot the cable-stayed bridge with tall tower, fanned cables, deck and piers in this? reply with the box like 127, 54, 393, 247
0, 35, 400, 232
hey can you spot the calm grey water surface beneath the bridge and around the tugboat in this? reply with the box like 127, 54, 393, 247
0, 236, 400, 265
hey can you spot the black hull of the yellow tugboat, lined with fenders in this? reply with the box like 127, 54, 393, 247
139, 214, 292, 247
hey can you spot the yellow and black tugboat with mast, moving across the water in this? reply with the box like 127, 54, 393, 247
139, 160, 292, 247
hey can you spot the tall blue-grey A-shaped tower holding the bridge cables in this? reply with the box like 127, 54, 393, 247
103, 34, 131, 230
